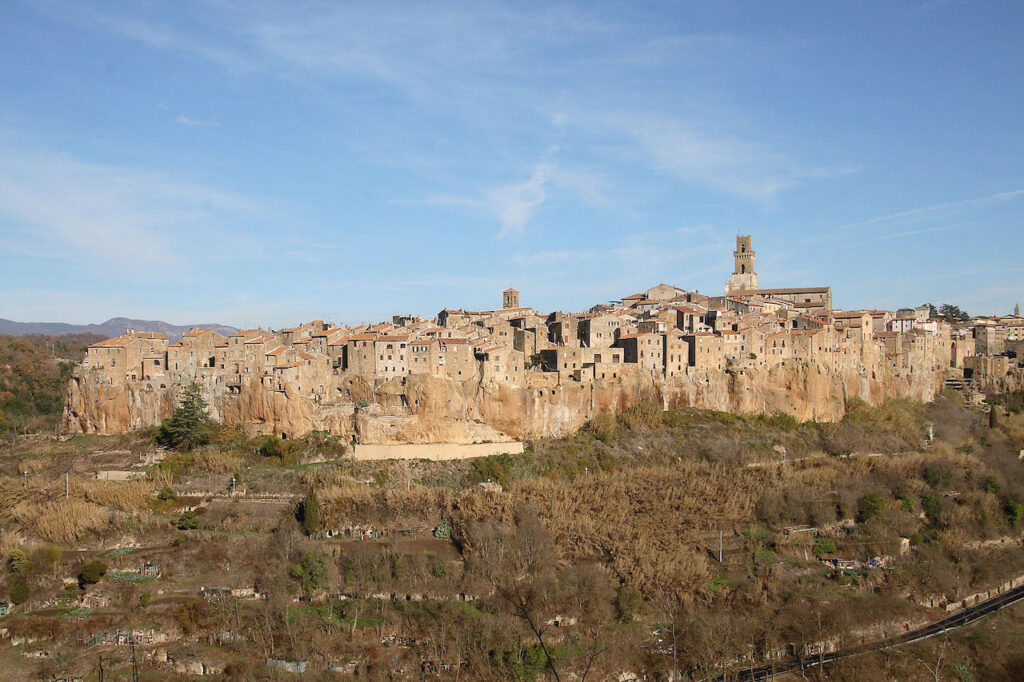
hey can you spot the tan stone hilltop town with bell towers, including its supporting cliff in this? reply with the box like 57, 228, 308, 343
63, 236, 1024, 443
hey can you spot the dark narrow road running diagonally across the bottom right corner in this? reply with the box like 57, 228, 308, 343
713, 586, 1024, 682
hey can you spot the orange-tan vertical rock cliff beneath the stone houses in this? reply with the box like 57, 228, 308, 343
63, 358, 946, 444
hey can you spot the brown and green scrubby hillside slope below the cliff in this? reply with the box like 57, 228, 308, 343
0, 394, 1024, 680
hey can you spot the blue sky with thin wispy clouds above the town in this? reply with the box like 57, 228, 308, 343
0, 0, 1024, 327
